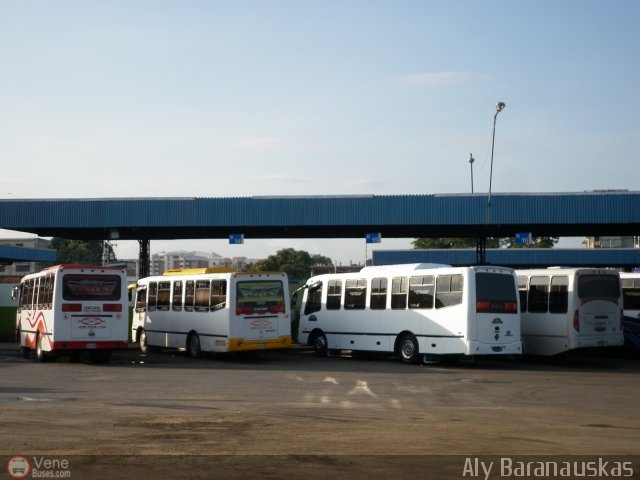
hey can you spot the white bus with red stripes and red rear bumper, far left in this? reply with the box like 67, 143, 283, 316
12, 265, 129, 362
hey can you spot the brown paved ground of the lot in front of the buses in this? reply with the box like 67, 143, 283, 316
0, 344, 640, 479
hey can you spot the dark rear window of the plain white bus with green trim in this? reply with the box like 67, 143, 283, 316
476, 272, 518, 313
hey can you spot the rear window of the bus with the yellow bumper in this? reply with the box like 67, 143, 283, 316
236, 280, 285, 315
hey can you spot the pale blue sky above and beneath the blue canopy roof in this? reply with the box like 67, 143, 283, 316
0, 0, 640, 263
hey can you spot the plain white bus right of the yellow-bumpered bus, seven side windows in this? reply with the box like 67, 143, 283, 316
298, 264, 522, 363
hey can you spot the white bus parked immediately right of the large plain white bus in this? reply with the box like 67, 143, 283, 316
516, 268, 624, 356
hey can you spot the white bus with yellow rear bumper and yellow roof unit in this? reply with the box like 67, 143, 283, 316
131, 268, 291, 357
